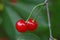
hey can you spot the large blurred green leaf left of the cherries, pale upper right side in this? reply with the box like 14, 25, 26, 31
3, 6, 21, 40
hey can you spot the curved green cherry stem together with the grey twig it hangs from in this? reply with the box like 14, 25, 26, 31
26, 0, 53, 40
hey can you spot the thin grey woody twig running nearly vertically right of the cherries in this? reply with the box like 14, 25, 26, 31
45, 0, 53, 40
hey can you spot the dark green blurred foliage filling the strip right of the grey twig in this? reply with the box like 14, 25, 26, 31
49, 0, 60, 40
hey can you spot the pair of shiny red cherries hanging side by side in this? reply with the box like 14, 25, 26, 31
16, 18, 37, 32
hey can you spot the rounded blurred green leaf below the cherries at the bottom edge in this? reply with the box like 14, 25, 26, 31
17, 33, 41, 40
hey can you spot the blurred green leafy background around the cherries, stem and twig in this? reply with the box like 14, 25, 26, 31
0, 0, 60, 40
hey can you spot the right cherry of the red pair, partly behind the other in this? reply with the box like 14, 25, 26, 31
27, 18, 37, 31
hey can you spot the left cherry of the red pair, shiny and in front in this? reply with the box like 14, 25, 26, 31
16, 19, 27, 32
